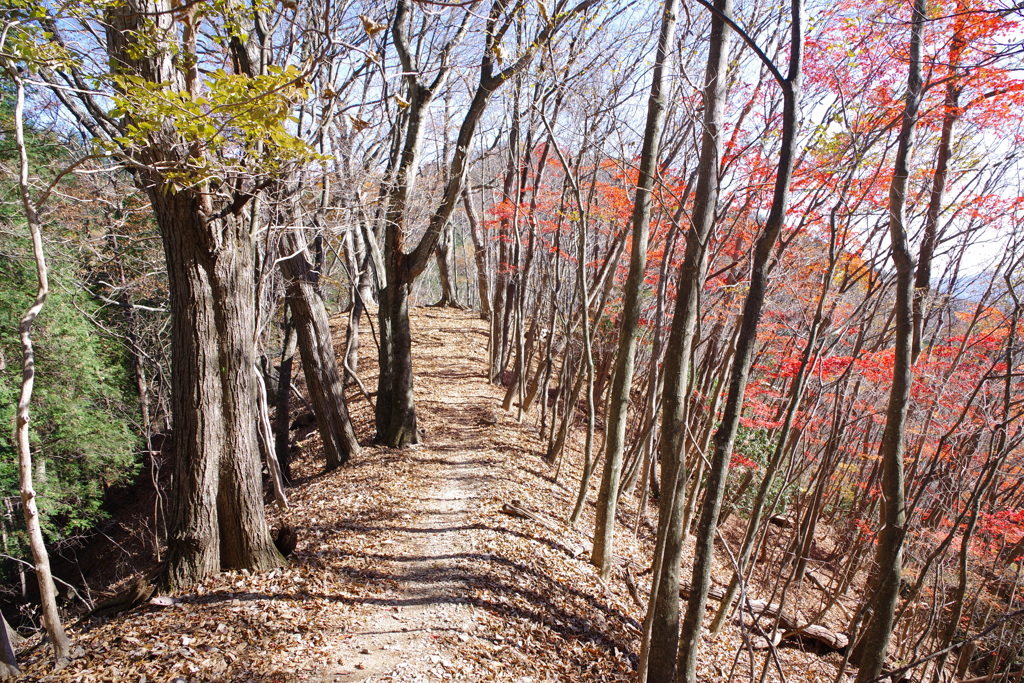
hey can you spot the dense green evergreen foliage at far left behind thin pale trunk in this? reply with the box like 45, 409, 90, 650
0, 232, 138, 550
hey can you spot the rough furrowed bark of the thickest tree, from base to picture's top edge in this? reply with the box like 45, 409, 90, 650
106, 0, 282, 587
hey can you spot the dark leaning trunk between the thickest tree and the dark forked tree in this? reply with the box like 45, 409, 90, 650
281, 228, 359, 470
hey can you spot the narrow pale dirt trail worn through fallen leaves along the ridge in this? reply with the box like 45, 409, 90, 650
321, 309, 524, 681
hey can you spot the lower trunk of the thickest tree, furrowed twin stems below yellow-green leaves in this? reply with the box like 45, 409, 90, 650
158, 189, 282, 587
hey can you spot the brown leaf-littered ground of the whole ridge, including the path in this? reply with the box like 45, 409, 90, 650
12, 308, 838, 683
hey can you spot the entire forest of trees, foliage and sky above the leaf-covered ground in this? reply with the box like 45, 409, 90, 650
0, 0, 1024, 681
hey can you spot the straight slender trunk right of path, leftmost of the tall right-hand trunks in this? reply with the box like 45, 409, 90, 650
590, 0, 679, 581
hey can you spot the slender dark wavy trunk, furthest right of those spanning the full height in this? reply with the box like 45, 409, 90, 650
854, 0, 928, 683
